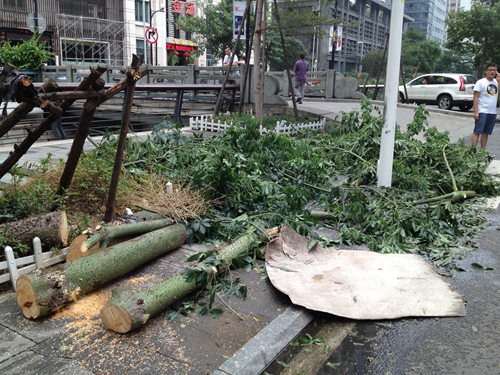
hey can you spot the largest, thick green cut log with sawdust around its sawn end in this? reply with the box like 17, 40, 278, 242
16, 224, 186, 319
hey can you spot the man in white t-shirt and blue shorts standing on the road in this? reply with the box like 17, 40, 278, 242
472, 63, 500, 148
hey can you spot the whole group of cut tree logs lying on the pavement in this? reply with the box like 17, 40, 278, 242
5, 212, 277, 333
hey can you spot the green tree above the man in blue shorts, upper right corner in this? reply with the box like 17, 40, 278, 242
446, 1, 500, 78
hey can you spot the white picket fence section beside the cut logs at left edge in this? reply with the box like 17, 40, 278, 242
0, 237, 67, 290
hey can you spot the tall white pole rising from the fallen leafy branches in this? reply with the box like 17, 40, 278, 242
377, 0, 405, 187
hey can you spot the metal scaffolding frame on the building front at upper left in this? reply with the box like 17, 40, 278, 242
57, 14, 126, 65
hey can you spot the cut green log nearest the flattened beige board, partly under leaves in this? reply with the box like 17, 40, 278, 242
100, 226, 277, 333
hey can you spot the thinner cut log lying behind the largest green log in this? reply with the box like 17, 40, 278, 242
66, 219, 174, 263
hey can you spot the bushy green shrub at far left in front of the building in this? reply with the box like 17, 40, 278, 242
0, 33, 53, 70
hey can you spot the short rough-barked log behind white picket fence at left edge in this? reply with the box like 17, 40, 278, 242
0, 211, 69, 246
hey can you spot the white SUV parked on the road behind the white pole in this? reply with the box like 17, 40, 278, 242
399, 73, 476, 112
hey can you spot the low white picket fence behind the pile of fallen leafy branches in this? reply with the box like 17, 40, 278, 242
189, 116, 326, 135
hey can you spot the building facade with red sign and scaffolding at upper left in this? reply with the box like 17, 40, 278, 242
0, 0, 196, 66
